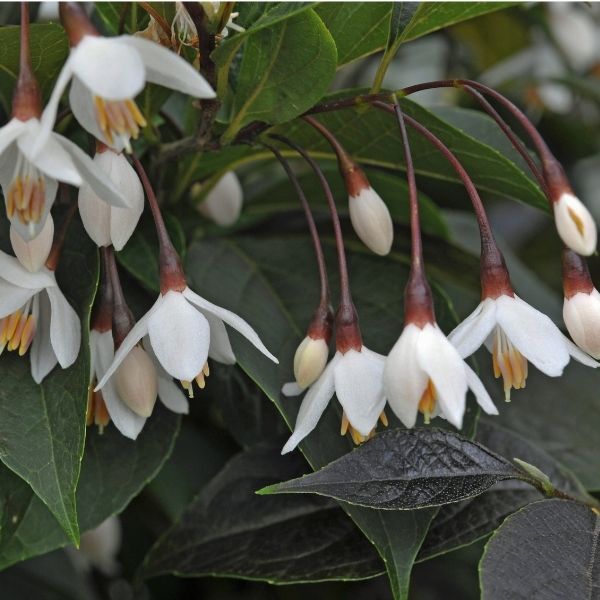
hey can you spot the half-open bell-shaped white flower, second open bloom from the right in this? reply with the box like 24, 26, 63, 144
383, 323, 498, 429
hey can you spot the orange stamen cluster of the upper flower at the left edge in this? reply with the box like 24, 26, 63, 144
6, 152, 46, 227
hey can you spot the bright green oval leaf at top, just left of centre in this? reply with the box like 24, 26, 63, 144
223, 10, 337, 141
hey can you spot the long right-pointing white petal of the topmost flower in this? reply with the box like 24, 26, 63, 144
113, 35, 215, 98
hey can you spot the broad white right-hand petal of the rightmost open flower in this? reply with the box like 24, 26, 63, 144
496, 295, 569, 377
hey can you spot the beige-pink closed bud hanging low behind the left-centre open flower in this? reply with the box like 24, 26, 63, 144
114, 346, 158, 417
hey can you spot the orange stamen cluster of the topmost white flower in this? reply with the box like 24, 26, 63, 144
94, 96, 147, 153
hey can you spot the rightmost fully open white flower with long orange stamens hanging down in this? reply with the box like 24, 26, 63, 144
448, 294, 598, 401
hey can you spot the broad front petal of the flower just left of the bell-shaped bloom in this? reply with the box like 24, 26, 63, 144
333, 346, 385, 436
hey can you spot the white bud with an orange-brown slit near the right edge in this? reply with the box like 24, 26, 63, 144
554, 192, 597, 256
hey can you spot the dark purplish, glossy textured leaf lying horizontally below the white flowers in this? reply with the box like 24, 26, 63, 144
259, 428, 523, 510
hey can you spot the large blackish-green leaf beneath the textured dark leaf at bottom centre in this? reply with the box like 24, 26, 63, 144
141, 447, 383, 583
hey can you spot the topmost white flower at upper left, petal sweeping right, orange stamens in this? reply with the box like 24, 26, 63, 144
42, 35, 215, 151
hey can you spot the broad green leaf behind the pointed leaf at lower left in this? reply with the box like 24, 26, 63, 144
0, 407, 180, 569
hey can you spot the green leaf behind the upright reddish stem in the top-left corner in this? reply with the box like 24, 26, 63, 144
0, 23, 69, 113
